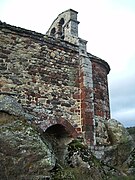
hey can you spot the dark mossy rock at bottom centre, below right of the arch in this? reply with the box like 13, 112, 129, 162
55, 139, 124, 180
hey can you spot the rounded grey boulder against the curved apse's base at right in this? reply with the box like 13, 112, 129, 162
103, 119, 135, 166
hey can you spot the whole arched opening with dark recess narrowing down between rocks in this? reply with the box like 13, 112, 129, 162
41, 118, 77, 165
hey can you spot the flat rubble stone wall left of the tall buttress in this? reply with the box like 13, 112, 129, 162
0, 23, 81, 137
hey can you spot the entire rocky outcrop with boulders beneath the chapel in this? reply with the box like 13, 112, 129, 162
0, 95, 135, 180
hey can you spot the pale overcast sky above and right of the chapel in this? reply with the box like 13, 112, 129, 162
0, 0, 135, 127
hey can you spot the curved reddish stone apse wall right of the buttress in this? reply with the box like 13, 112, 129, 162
92, 57, 110, 119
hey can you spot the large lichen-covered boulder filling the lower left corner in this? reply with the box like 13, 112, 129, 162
0, 112, 55, 180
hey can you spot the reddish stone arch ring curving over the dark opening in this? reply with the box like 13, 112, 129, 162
40, 118, 78, 138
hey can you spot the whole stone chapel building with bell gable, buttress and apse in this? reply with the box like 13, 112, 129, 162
0, 9, 110, 145
